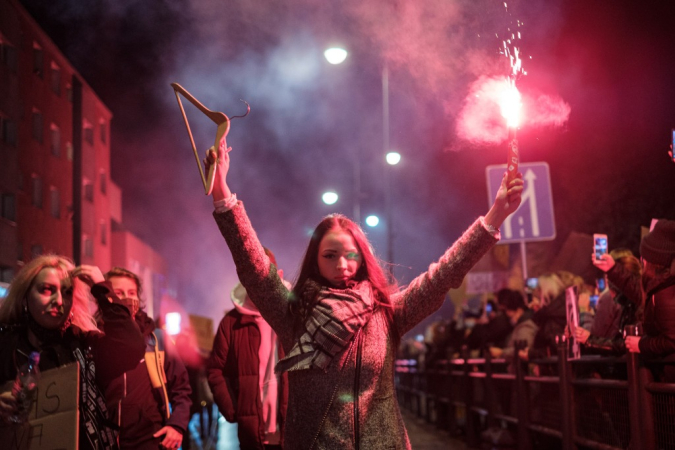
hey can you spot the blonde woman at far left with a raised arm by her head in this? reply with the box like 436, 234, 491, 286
0, 255, 145, 450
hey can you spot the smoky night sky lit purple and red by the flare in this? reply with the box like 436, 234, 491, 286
22, 0, 675, 336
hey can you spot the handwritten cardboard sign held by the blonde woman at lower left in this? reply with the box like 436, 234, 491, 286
0, 363, 80, 450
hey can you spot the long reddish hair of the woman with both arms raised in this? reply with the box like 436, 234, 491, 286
291, 214, 396, 321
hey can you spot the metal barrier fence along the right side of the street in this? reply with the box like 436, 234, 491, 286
396, 339, 675, 450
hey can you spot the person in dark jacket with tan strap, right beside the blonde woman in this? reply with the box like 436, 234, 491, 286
105, 267, 192, 450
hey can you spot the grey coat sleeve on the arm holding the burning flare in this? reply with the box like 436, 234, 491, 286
392, 219, 497, 336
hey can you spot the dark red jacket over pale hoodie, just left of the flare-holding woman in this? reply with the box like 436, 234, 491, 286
207, 283, 288, 449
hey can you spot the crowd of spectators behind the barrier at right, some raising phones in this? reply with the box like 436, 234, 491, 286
400, 220, 675, 381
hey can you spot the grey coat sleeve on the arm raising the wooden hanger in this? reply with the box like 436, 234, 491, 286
213, 201, 293, 342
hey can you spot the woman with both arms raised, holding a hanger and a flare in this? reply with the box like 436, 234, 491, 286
201, 132, 523, 450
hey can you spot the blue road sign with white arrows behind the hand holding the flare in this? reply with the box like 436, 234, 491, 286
485, 162, 555, 244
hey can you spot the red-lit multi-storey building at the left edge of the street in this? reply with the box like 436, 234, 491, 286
0, 0, 174, 313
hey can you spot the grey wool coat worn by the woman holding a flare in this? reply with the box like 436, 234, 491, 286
214, 202, 497, 450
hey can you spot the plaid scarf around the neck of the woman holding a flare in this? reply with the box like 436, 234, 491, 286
275, 281, 374, 373
